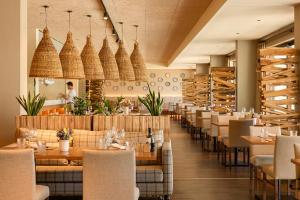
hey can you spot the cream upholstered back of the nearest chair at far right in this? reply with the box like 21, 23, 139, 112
274, 136, 300, 179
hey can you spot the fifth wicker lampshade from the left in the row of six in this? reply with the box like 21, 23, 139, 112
115, 41, 135, 81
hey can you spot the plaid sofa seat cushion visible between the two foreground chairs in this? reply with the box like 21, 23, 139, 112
36, 166, 82, 183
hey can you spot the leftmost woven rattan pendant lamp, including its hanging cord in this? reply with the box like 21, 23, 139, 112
29, 6, 63, 78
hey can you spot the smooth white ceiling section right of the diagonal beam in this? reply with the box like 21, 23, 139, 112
169, 0, 300, 66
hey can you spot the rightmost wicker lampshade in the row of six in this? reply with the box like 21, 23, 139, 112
130, 42, 147, 82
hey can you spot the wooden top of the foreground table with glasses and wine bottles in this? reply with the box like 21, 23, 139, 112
4, 144, 157, 161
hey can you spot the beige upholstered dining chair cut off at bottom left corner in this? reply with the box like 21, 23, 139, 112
0, 149, 49, 200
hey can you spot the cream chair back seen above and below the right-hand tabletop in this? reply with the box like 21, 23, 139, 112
250, 126, 281, 156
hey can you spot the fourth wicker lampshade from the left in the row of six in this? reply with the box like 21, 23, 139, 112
98, 38, 120, 80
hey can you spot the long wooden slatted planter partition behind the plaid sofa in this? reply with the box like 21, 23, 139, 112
16, 115, 170, 138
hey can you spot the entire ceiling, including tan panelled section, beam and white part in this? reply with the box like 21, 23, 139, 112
28, 0, 300, 67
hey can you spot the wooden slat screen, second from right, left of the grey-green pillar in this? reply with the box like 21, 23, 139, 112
211, 67, 236, 113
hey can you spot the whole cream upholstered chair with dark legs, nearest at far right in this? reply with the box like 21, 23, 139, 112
262, 136, 300, 200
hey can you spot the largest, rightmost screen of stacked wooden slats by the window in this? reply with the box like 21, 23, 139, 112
257, 48, 299, 129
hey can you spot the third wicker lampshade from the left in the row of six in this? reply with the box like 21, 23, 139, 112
81, 35, 104, 80
